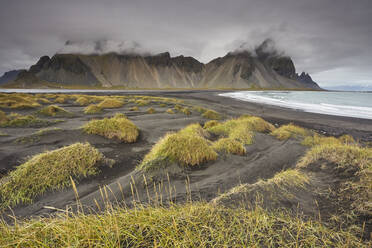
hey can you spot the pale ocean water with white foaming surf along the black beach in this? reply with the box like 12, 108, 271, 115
219, 91, 372, 119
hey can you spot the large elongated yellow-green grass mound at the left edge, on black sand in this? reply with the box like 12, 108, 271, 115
0, 143, 104, 208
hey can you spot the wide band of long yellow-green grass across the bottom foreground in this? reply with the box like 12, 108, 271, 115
0, 203, 370, 248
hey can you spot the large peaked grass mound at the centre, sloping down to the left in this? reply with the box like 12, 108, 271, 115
140, 124, 217, 170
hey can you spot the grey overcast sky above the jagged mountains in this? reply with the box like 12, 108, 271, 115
0, 0, 372, 87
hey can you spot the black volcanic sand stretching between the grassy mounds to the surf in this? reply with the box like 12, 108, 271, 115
0, 91, 372, 217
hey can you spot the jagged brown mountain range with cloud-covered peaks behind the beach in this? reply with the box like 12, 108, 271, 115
3, 41, 320, 89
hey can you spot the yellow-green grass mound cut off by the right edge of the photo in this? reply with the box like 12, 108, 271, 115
297, 143, 372, 215
